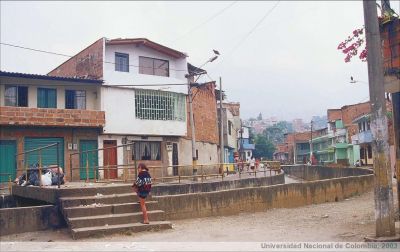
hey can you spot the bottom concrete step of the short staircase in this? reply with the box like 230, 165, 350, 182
71, 220, 172, 239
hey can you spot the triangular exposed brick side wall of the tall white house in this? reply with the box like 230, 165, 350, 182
48, 38, 104, 79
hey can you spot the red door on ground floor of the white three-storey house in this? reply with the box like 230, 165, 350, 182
103, 140, 118, 179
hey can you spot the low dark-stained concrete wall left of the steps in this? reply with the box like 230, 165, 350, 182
0, 205, 65, 236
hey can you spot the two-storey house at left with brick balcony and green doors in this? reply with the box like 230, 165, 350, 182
0, 71, 105, 182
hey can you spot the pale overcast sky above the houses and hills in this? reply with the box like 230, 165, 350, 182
0, 1, 399, 121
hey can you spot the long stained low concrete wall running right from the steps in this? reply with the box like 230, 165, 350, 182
153, 175, 374, 220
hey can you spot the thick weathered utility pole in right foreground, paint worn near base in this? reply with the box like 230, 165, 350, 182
363, 0, 395, 237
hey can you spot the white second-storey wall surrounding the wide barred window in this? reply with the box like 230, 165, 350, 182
101, 87, 187, 136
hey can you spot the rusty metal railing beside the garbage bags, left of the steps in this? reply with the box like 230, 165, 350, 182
15, 143, 60, 188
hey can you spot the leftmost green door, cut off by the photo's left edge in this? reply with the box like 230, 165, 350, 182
0, 140, 17, 183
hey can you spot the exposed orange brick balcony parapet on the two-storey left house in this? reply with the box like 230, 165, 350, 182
0, 107, 105, 127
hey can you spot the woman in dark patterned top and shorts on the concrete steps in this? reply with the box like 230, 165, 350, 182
132, 163, 151, 224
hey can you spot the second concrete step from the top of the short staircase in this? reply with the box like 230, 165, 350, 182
64, 201, 157, 218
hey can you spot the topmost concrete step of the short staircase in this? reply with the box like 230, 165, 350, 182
60, 193, 151, 208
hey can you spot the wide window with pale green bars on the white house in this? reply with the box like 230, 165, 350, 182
135, 89, 186, 121
